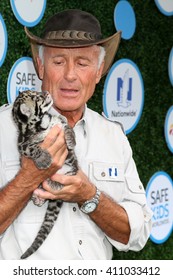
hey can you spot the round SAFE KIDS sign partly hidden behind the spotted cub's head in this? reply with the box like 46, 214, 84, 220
7, 57, 41, 103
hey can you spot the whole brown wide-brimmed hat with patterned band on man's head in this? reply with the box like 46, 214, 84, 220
24, 9, 121, 76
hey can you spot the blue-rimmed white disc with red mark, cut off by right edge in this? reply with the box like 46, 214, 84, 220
164, 106, 173, 153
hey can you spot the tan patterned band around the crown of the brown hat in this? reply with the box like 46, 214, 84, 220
44, 30, 102, 41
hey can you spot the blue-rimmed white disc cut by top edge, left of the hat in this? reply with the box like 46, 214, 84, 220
10, 0, 46, 27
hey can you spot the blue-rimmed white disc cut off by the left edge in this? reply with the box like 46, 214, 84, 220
0, 14, 8, 67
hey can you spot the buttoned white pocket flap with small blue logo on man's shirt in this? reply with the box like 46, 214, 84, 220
92, 162, 124, 181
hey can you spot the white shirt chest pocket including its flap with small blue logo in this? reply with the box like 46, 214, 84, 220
89, 162, 125, 202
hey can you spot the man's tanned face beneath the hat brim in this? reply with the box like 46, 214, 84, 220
38, 46, 103, 112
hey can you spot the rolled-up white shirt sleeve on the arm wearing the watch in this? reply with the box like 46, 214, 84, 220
107, 131, 153, 251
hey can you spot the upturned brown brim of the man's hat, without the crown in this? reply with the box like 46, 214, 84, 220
24, 27, 121, 76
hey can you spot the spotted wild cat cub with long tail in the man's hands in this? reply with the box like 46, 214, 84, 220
12, 90, 78, 259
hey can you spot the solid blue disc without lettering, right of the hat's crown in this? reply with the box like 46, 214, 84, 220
114, 0, 136, 40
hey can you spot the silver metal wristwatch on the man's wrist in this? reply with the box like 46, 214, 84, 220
80, 188, 101, 214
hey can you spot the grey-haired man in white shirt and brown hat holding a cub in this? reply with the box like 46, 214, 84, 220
0, 10, 151, 260
